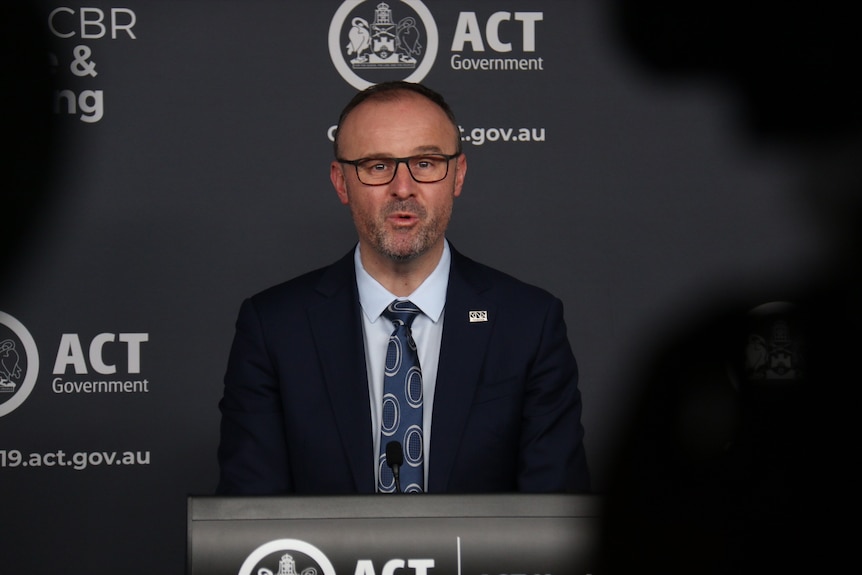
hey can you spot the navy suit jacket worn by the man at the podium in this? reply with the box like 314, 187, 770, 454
217, 249, 589, 494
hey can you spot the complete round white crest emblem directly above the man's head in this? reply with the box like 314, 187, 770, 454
329, 0, 439, 90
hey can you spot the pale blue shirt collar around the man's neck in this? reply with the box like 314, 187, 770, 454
353, 240, 452, 323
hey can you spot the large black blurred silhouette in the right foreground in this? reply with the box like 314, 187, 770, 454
601, 0, 862, 574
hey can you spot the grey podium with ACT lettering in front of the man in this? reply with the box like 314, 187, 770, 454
187, 494, 600, 575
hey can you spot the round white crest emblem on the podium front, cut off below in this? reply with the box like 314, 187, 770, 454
239, 539, 335, 575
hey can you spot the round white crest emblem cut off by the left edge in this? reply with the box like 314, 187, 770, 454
0, 311, 39, 417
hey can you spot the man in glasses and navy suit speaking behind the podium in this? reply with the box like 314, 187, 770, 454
218, 82, 589, 494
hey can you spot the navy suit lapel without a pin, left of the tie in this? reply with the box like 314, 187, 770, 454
308, 251, 374, 493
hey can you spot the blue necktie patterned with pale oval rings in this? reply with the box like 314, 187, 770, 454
377, 300, 425, 493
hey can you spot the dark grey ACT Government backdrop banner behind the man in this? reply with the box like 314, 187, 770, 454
0, 0, 840, 574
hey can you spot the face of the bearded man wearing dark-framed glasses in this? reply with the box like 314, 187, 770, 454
330, 92, 467, 262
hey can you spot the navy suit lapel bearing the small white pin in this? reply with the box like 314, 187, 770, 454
428, 248, 497, 492
